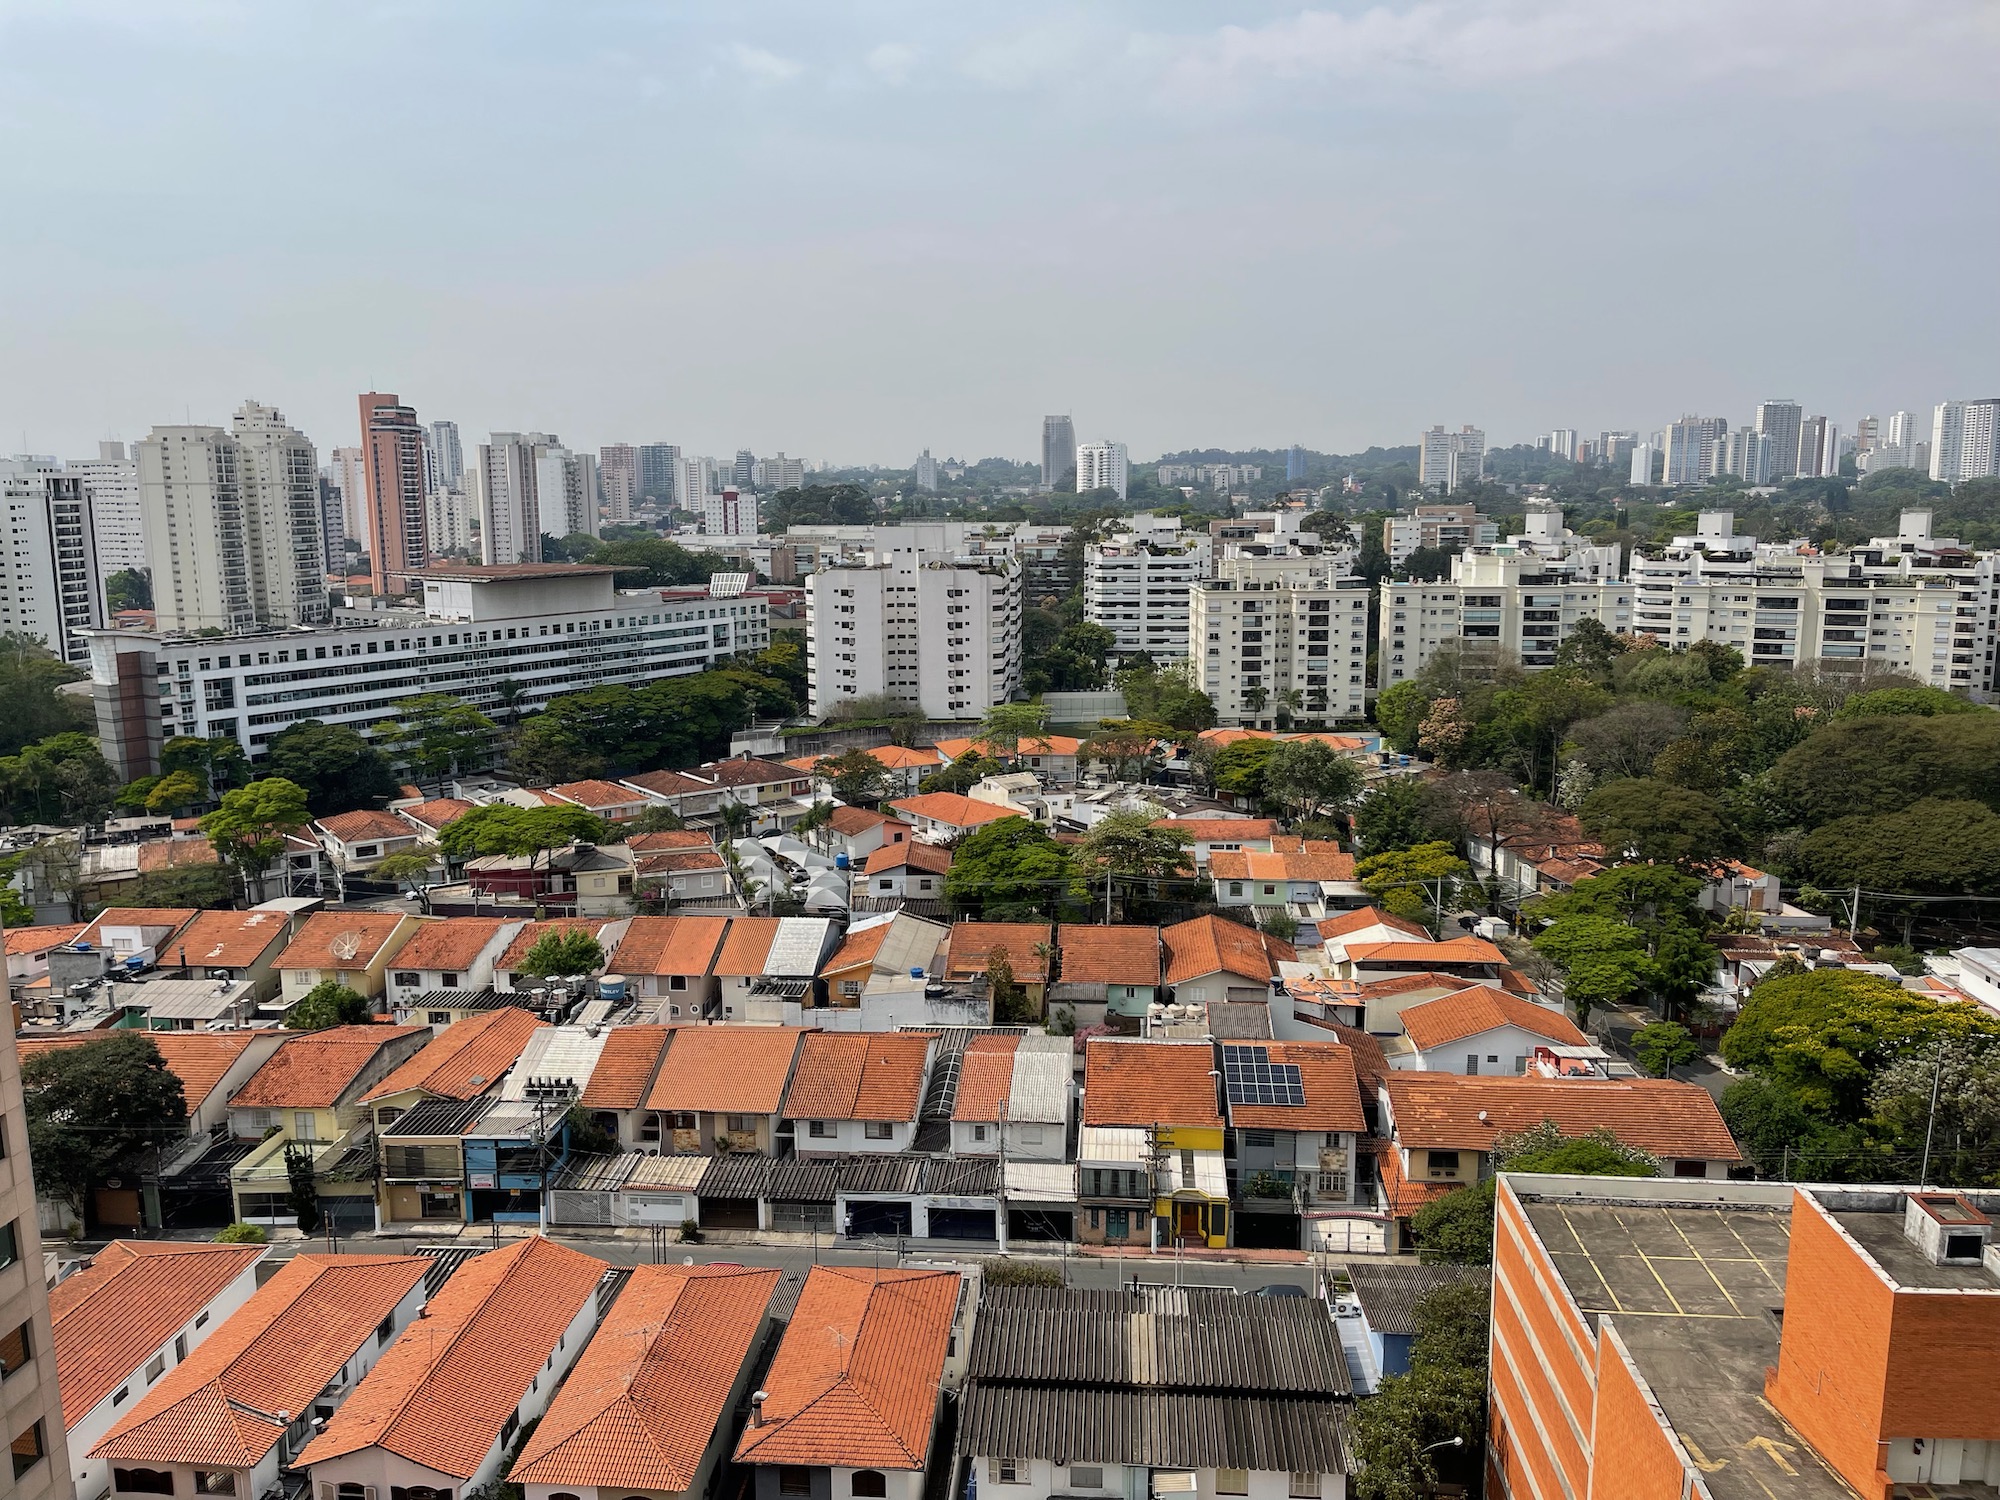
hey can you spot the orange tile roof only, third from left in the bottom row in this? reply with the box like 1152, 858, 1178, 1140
296, 1238, 606, 1480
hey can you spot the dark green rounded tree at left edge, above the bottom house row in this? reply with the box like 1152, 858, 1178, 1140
20, 1032, 188, 1224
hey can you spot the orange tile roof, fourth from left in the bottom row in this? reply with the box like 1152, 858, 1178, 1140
508, 1266, 778, 1494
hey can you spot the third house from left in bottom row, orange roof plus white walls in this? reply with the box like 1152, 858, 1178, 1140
298, 1238, 606, 1498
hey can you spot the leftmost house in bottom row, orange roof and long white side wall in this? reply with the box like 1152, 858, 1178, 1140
48, 1240, 268, 1500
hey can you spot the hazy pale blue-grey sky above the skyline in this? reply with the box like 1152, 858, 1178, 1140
0, 0, 2000, 464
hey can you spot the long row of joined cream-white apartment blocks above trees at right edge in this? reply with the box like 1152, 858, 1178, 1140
1376, 510, 2000, 700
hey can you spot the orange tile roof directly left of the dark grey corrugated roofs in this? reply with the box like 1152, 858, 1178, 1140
736, 1266, 958, 1470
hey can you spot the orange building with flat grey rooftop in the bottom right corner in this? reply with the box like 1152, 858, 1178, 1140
1486, 1174, 2000, 1500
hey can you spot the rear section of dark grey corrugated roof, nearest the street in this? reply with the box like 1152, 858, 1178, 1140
966, 1286, 1352, 1396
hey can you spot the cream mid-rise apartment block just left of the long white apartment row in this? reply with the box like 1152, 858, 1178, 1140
1192, 534, 1368, 728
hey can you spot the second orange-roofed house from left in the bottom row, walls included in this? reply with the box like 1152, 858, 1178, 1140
88, 1254, 432, 1500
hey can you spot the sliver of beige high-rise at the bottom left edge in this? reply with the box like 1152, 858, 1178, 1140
0, 1024, 76, 1500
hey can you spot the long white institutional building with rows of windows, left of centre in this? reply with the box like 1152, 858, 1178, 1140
88, 564, 770, 780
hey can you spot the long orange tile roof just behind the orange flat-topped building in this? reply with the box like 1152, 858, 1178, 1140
1386, 1072, 1742, 1162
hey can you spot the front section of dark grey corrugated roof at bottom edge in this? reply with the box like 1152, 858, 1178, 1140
958, 1380, 1350, 1474
